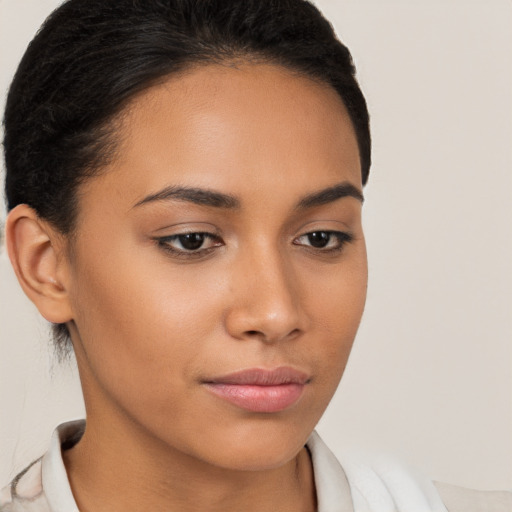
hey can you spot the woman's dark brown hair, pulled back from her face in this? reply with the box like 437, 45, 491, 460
4, 0, 370, 348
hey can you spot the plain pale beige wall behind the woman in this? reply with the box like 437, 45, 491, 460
0, 0, 512, 489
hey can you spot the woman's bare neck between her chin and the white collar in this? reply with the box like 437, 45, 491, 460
63, 414, 316, 512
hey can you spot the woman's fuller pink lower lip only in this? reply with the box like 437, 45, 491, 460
206, 383, 304, 412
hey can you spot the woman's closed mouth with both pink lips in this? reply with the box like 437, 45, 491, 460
204, 367, 311, 413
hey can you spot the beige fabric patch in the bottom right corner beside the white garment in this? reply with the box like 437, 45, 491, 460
434, 482, 512, 512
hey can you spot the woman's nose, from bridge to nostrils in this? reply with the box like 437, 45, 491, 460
225, 245, 305, 343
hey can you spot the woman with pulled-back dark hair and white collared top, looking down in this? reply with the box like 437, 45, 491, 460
0, 0, 510, 512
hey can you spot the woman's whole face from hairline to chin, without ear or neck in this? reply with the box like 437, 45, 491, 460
67, 64, 367, 469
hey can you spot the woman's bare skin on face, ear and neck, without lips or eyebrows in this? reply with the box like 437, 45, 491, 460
7, 64, 367, 512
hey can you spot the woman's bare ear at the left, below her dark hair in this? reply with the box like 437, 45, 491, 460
5, 204, 73, 323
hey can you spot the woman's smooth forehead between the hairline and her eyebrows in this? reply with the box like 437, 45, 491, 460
83, 64, 361, 212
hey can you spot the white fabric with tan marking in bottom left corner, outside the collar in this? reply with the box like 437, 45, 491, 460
0, 459, 50, 512
